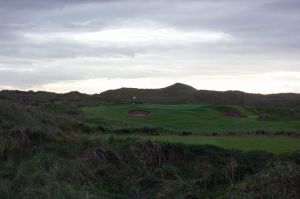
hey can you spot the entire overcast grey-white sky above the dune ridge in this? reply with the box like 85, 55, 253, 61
0, 0, 300, 93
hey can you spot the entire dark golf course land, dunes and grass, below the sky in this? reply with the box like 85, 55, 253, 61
0, 84, 300, 199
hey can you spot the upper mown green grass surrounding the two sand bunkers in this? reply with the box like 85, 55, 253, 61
81, 104, 300, 132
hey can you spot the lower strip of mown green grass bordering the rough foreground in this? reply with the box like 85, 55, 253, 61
88, 134, 300, 154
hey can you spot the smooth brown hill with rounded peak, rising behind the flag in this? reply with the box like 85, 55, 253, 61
97, 83, 300, 108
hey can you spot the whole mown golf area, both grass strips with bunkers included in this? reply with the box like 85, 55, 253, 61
81, 104, 300, 154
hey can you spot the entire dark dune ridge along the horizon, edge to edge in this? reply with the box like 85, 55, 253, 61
0, 83, 300, 109
